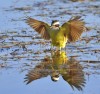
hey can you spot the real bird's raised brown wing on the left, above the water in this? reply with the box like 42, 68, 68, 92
26, 18, 50, 40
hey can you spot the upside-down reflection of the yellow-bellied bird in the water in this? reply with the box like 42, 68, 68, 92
25, 51, 85, 90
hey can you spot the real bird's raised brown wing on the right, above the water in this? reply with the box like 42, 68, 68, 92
61, 16, 85, 42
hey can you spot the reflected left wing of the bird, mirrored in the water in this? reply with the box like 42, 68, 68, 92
24, 61, 50, 84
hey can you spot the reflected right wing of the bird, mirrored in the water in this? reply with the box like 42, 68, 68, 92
62, 58, 86, 91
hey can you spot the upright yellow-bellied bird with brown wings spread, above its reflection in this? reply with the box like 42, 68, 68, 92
27, 16, 85, 49
